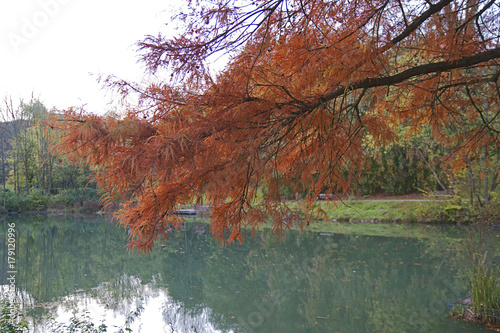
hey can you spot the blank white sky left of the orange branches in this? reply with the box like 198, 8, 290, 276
0, 0, 182, 113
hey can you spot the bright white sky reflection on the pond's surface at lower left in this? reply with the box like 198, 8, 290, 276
29, 276, 229, 333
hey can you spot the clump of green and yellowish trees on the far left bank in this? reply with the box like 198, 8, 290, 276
0, 97, 97, 211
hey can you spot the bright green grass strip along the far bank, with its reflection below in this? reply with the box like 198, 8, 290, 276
187, 198, 499, 238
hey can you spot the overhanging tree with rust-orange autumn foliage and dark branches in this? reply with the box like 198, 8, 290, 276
47, 0, 500, 250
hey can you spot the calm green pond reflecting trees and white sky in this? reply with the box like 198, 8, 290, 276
0, 215, 498, 333
